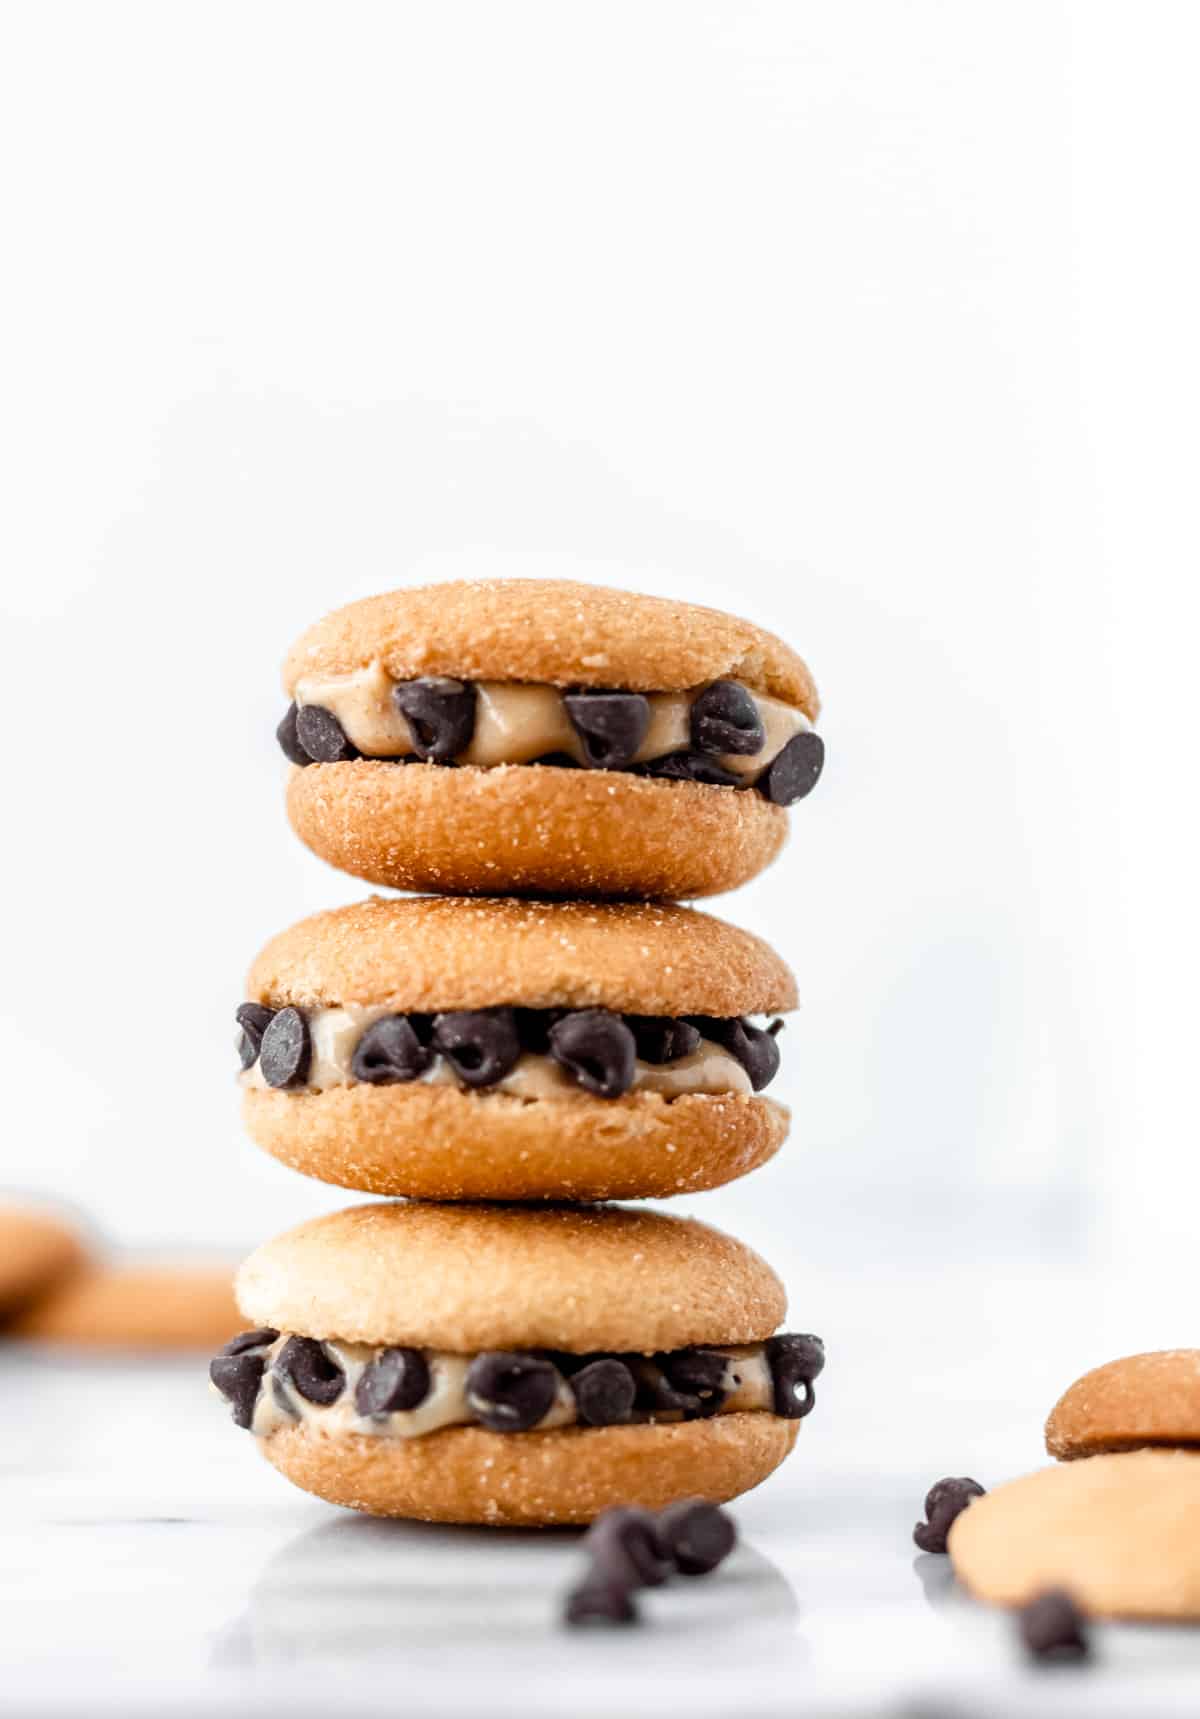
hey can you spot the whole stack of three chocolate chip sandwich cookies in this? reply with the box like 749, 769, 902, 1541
211, 581, 823, 1525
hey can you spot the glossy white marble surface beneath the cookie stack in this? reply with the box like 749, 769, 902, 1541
0, 1306, 1200, 1719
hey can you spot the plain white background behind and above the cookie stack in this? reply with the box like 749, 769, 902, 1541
0, 0, 1200, 1327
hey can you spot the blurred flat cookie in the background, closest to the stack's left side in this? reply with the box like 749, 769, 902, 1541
9, 1263, 241, 1349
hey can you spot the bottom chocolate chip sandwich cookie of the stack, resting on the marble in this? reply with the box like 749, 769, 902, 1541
211, 1203, 823, 1526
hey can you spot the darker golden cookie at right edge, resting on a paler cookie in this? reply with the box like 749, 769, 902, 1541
1045, 1349, 1200, 1461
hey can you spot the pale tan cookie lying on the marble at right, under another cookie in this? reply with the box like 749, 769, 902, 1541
947, 1449, 1200, 1621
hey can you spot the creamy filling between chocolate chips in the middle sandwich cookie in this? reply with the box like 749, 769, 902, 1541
239, 1004, 753, 1102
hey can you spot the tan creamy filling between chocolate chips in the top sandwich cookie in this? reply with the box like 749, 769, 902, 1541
294, 662, 811, 784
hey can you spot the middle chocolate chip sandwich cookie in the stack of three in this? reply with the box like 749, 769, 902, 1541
237, 897, 796, 1200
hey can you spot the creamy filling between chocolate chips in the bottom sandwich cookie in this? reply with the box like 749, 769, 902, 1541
238, 1334, 775, 1439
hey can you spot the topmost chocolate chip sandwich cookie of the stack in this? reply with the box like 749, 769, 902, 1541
279, 579, 823, 897
